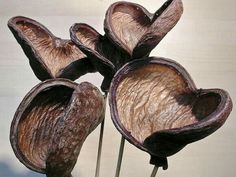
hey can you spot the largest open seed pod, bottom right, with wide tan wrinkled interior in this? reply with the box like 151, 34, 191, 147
109, 58, 232, 169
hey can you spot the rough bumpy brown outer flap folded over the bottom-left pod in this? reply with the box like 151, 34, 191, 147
46, 83, 104, 177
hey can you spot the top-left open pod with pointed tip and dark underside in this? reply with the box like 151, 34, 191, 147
8, 16, 94, 80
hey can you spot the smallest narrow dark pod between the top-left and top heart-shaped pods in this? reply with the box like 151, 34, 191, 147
70, 23, 130, 90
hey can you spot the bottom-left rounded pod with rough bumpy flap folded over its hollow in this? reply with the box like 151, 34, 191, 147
10, 79, 105, 177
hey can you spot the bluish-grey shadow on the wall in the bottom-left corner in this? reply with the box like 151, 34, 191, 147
0, 162, 42, 177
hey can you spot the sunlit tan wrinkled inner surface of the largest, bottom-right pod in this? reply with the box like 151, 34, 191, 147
117, 64, 197, 142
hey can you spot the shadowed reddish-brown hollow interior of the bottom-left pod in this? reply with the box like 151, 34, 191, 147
18, 87, 73, 168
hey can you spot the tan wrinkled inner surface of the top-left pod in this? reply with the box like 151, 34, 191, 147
16, 21, 85, 76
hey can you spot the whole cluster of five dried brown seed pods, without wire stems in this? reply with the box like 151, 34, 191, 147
8, 0, 232, 177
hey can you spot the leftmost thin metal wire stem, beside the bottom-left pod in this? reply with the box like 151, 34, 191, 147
95, 93, 107, 177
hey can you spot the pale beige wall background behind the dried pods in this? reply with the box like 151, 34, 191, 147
0, 0, 236, 177
